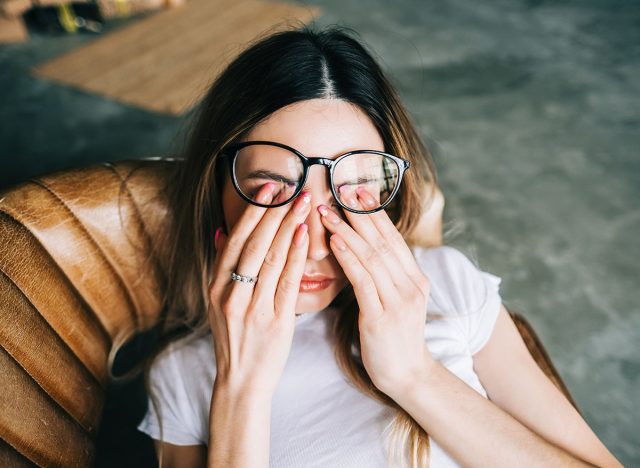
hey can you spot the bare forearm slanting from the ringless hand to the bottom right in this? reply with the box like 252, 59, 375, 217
391, 360, 592, 467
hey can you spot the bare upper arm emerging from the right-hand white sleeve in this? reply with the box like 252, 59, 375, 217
473, 306, 622, 466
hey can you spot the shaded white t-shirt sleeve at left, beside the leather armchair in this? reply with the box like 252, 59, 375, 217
138, 343, 203, 445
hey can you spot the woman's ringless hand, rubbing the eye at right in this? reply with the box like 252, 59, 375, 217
318, 187, 433, 398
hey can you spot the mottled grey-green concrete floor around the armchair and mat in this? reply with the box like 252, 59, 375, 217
0, 0, 640, 466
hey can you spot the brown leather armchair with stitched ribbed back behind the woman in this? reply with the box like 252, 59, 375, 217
0, 158, 575, 466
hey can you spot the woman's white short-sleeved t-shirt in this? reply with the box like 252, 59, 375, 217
138, 246, 501, 468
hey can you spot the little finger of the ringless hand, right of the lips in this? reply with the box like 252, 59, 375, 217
329, 234, 383, 319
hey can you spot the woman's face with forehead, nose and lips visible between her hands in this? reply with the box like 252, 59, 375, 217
222, 99, 384, 314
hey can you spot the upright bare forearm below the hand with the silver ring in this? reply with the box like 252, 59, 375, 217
207, 385, 271, 468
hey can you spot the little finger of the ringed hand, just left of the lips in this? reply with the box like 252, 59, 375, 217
274, 223, 309, 317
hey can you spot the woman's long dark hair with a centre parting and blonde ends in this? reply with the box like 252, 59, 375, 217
145, 22, 437, 468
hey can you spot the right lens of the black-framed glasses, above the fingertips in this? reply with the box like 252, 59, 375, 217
333, 153, 399, 206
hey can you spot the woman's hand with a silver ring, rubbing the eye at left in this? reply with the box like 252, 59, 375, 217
208, 184, 310, 399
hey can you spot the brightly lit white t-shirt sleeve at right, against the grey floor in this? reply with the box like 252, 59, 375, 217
413, 246, 502, 355
